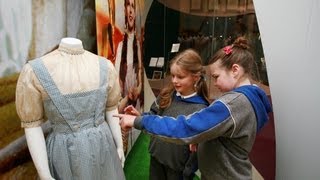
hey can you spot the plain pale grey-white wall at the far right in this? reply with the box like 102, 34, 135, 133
254, 0, 320, 180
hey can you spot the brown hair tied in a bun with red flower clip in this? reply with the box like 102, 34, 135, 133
209, 37, 254, 76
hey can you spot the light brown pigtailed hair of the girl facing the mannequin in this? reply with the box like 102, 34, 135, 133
159, 49, 209, 109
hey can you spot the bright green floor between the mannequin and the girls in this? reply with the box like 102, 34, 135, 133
124, 133, 199, 180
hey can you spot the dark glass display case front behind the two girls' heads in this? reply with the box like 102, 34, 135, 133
144, 0, 269, 99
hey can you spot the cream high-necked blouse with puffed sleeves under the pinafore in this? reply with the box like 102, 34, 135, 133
16, 43, 121, 128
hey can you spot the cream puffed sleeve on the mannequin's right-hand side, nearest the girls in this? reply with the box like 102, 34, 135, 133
106, 61, 121, 111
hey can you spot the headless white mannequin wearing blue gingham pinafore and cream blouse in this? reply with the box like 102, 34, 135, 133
16, 38, 125, 180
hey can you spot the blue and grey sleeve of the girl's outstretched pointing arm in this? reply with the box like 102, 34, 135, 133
134, 101, 235, 144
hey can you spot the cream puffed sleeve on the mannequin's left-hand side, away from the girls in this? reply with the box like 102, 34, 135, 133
16, 64, 44, 128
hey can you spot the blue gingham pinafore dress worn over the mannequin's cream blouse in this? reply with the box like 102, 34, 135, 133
29, 58, 125, 180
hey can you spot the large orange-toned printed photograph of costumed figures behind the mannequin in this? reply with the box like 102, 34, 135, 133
96, 0, 150, 154
